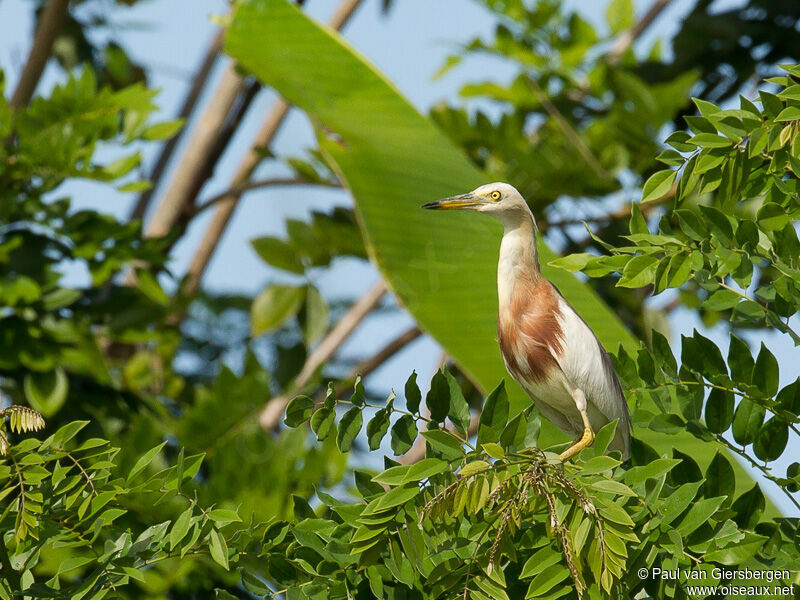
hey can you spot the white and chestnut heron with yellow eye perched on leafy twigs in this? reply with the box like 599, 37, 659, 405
423, 183, 631, 461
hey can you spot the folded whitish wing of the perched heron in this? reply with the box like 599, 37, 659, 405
554, 293, 631, 457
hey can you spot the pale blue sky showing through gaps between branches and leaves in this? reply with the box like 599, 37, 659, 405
0, 0, 800, 511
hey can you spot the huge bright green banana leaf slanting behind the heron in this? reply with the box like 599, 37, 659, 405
226, 0, 776, 506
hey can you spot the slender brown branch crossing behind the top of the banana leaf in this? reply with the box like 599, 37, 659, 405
183, 0, 361, 296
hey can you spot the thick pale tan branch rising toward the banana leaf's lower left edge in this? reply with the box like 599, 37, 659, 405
258, 280, 386, 430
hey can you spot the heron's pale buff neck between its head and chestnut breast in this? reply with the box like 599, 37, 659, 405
497, 206, 542, 311
